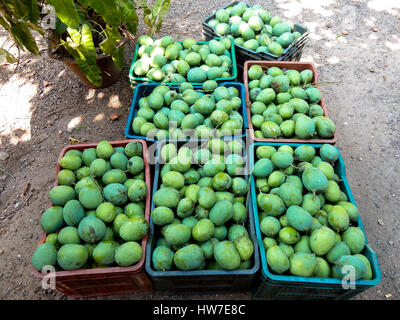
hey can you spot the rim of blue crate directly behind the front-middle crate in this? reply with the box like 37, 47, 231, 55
124, 81, 249, 143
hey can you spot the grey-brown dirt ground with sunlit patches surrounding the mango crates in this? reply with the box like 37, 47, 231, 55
0, 0, 400, 300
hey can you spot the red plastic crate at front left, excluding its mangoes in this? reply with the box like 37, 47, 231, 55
32, 139, 153, 298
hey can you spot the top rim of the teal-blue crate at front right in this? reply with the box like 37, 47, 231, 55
249, 142, 382, 288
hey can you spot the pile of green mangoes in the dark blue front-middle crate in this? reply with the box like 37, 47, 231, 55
151, 139, 254, 271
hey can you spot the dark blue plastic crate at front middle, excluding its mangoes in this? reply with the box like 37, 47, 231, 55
145, 141, 260, 295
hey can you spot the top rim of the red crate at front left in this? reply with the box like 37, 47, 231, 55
31, 139, 151, 279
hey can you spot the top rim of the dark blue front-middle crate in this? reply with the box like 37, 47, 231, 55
145, 141, 261, 278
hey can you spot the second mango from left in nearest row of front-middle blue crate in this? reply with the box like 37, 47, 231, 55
174, 244, 205, 271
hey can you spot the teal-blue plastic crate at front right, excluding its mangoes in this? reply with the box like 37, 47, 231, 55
249, 142, 382, 299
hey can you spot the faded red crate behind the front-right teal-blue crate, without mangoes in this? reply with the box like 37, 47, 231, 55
243, 60, 337, 144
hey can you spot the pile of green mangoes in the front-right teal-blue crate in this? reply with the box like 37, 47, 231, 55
253, 144, 373, 280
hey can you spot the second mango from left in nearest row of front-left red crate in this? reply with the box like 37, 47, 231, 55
57, 244, 88, 270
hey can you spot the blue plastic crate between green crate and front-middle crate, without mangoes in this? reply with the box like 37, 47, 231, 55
125, 82, 249, 142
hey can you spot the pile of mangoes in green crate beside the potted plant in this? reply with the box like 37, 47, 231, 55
132, 35, 236, 83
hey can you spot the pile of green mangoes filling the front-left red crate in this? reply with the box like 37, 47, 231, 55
32, 140, 148, 271
